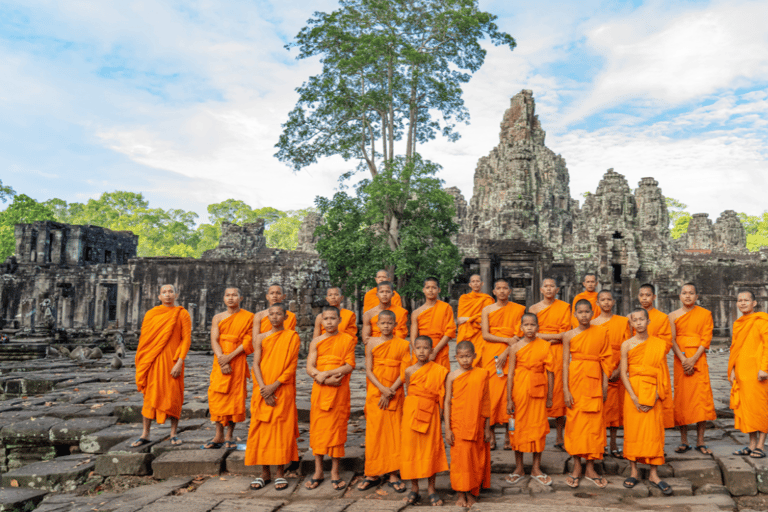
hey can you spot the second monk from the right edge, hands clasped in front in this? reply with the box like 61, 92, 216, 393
669, 283, 717, 455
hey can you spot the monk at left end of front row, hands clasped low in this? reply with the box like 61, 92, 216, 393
245, 304, 301, 491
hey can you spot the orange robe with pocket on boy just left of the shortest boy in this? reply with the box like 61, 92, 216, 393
400, 361, 448, 480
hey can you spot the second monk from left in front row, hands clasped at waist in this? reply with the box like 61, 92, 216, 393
306, 306, 357, 490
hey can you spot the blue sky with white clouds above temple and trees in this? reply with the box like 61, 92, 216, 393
0, 0, 768, 220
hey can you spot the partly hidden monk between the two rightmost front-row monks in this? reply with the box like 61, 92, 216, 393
590, 290, 632, 459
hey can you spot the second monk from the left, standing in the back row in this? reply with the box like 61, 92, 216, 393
206, 287, 253, 449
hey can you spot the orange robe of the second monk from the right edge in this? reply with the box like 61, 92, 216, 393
675, 306, 717, 426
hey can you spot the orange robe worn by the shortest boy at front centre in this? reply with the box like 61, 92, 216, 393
451, 368, 491, 496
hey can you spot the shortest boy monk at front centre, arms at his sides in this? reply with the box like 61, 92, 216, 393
444, 340, 491, 507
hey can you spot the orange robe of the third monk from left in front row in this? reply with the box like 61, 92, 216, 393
365, 338, 411, 476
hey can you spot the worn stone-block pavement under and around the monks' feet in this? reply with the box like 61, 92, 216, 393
0, 349, 768, 512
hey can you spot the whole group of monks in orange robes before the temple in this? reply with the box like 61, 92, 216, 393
133, 270, 768, 507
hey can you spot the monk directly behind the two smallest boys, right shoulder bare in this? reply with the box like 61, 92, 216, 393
411, 277, 456, 371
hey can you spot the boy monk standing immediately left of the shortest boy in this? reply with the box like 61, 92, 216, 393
400, 336, 448, 506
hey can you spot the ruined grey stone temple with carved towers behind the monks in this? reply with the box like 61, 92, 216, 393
0, 90, 768, 348
